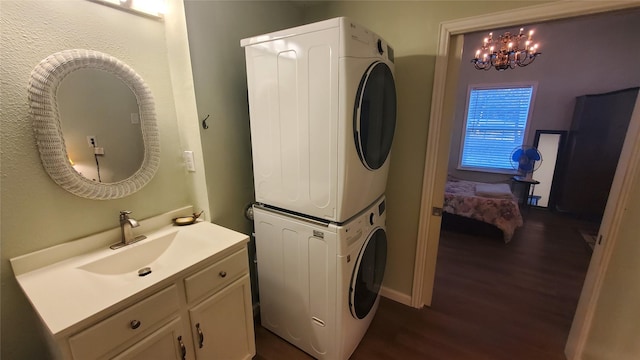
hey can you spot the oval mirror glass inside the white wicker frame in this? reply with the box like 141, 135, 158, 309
56, 68, 144, 183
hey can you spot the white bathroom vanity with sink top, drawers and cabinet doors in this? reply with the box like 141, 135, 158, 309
11, 211, 255, 360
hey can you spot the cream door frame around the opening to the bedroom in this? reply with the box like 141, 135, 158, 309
411, 0, 640, 358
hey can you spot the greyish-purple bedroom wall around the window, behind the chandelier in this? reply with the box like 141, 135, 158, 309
449, 9, 640, 181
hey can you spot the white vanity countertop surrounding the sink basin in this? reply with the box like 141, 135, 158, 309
12, 217, 248, 335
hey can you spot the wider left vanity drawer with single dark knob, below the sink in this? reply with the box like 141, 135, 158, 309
69, 285, 179, 360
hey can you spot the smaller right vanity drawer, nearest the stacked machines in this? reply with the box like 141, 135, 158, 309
184, 248, 249, 303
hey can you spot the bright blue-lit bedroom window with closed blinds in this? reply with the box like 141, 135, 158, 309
460, 84, 535, 173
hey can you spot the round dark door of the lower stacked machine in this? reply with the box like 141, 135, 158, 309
349, 227, 387, 319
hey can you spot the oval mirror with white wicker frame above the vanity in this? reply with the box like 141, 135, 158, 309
28, 49, 160, 200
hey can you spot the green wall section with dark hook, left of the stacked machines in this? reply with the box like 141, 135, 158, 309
185, 1, 303, 234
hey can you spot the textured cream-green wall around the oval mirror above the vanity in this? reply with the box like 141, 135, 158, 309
0, 0, 193, 359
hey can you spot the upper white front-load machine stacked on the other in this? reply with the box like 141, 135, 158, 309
241, 18, 396, 223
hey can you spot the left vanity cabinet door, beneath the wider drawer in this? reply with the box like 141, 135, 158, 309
112, 318, 193, 360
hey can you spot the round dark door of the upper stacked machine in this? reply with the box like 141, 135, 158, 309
353, 61, 396, 170
